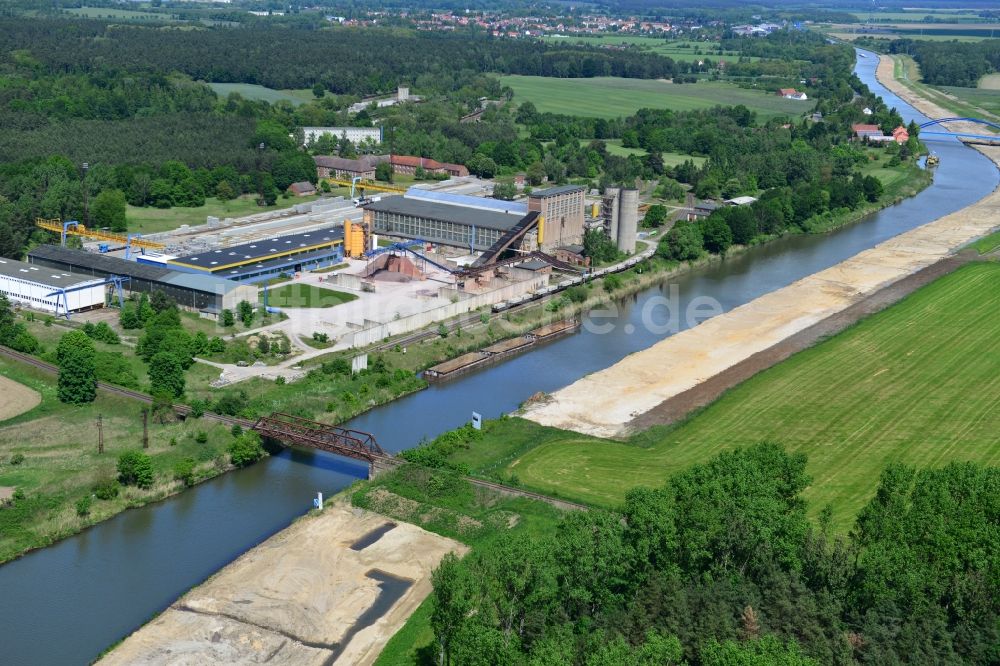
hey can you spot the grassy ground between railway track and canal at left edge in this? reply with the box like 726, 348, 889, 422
0, 357, 240, 563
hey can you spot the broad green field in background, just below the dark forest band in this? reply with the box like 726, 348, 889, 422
500, 75, 815, 120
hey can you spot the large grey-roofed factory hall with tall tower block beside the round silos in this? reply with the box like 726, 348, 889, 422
364, 185, 584, 252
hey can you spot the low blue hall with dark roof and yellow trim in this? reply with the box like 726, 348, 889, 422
164, 227, 344, 282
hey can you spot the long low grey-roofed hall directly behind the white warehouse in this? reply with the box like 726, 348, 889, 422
28, 245, 257, 312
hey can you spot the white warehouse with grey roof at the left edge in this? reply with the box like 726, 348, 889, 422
0, 259, 106, 315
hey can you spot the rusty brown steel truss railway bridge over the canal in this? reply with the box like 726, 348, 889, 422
253, 412, 402, 478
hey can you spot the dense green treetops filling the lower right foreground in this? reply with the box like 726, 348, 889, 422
431, 444, 1000, 666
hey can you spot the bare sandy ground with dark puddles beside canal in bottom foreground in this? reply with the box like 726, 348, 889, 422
100, 500, 467, 665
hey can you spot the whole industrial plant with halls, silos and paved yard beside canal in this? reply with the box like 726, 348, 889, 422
28, 177, 638, 366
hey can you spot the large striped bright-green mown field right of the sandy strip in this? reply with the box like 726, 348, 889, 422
442, 262, 1000, 531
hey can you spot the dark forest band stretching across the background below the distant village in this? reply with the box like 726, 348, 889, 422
0, 19, 690, 95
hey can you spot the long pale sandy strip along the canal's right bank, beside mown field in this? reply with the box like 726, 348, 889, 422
524, 91, 1000, 437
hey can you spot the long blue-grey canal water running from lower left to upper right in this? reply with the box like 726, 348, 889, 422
0, 49, 998, 664
